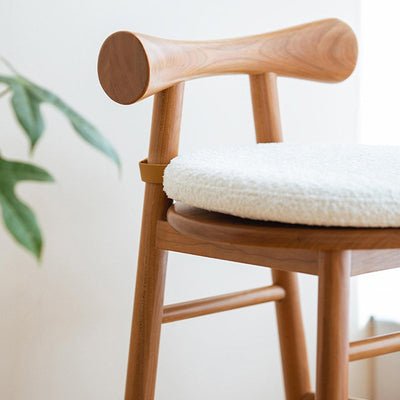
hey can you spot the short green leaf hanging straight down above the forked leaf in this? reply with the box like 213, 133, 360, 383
11, 80, 44, 151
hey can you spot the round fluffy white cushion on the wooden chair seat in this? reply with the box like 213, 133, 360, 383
164, 143, 400, 227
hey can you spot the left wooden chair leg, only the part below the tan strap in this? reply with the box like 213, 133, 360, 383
125, 184, 168, 400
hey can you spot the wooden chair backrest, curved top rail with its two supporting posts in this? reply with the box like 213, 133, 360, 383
98, 19, 357, 188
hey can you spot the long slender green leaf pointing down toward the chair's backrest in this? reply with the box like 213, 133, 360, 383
19, 77, 120, 167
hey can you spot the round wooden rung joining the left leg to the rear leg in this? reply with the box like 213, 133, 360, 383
162, 285, 285, 323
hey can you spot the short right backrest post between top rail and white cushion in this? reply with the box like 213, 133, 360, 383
250, 73, 282, 143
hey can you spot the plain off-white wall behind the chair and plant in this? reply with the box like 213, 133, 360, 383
0, 0, 363, 400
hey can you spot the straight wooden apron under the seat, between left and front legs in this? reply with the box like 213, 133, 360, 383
157, 221, 318, 275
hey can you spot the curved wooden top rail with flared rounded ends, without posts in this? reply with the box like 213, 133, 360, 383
98, 19, 357, 104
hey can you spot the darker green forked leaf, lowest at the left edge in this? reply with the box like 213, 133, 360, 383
0, 157, 53, 259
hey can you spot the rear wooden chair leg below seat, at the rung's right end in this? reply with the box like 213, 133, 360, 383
272, 270, 311, 400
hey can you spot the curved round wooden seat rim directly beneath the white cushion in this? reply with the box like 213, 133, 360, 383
167, 203, 400, 250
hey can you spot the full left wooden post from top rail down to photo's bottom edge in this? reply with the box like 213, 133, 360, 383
125, 84, 183, 400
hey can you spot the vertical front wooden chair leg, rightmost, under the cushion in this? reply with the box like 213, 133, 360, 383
315, 251, 350, 400
